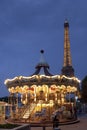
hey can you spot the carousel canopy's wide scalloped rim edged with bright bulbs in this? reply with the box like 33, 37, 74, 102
5, 75, 80, 87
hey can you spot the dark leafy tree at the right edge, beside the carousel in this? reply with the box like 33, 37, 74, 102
81, 76, 87, 103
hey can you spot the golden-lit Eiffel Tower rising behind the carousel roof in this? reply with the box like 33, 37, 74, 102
61, 20, 74, 77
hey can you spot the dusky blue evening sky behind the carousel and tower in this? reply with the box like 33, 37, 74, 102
0, 0, 87, 97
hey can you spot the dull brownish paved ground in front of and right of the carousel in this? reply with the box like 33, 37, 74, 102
31, 114, 87, 130
